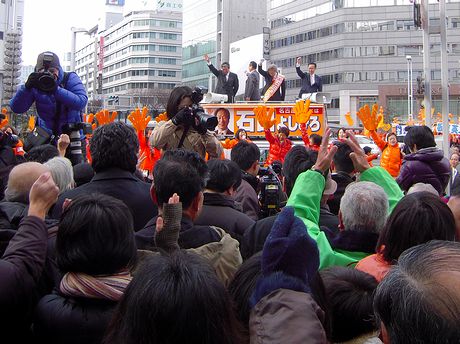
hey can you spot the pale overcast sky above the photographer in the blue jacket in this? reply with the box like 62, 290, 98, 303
22, 0, 146, 65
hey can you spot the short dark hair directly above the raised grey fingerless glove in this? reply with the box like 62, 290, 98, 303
153, 150, 207, 209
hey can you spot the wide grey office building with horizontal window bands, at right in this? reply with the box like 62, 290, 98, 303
268, 0, 460, 122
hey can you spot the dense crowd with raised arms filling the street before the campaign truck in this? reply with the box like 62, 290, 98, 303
0, 49, 460, 344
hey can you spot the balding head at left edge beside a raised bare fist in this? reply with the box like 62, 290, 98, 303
5, 162, 49, 204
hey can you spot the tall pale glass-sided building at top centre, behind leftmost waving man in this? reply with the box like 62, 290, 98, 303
182, 0, 267, 87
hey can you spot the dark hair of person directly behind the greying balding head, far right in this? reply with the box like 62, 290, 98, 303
377, 192, 456, 264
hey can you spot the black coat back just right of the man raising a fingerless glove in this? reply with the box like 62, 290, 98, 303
194, 192, 255, 242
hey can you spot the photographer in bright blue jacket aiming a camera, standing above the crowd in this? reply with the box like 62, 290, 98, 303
10, 51, 88, 165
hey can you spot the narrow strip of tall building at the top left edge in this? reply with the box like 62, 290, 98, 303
0, 0, 24, 105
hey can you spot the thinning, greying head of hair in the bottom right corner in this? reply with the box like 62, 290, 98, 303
374, 240, 460, 344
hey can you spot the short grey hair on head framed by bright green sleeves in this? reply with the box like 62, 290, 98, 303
340, 182, 388, 233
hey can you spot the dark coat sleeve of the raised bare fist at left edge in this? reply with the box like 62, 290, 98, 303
0, 216, 48, 343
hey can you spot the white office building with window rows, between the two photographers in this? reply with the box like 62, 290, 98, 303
75, 0, 182, 113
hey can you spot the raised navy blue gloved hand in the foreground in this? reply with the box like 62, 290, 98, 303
250, 207, 319, 307
